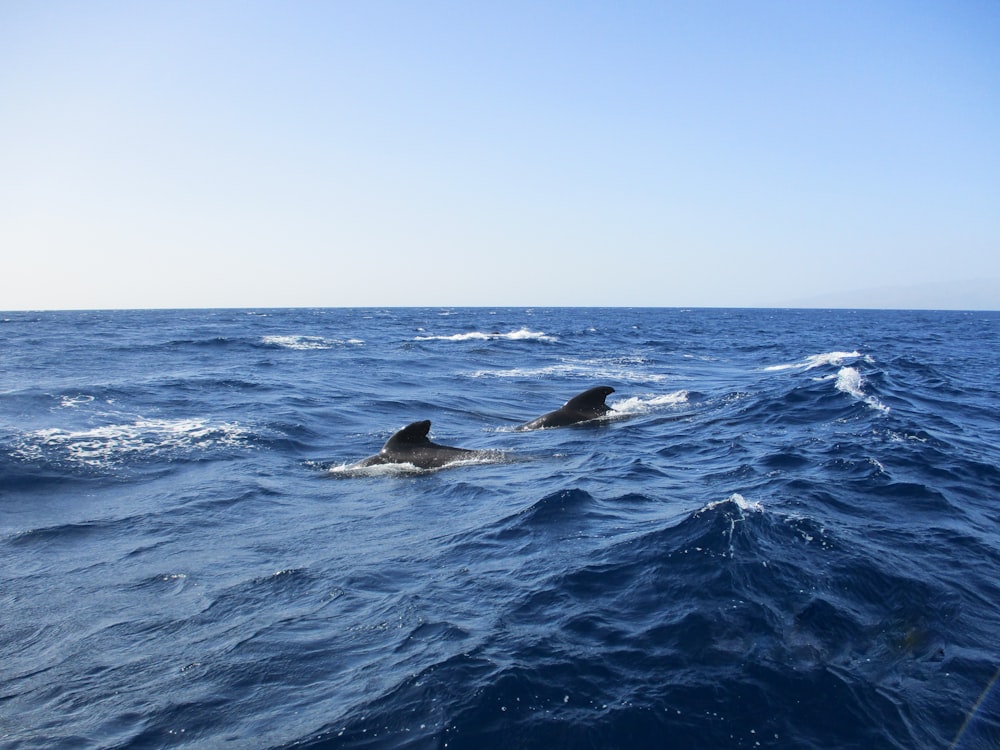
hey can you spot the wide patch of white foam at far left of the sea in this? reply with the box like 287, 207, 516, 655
14, 419, 250, 466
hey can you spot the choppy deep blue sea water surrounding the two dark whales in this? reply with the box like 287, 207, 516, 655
0, 308, 1000, 749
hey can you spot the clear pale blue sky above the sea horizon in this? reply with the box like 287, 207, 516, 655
0, 0, 1000, 310
